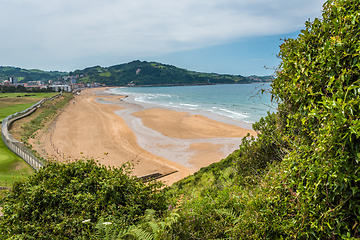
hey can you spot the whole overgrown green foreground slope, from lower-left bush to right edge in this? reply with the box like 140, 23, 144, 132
0, 0, 360, 237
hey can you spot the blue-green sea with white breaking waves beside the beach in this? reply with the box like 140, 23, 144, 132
109, 83, 277, 126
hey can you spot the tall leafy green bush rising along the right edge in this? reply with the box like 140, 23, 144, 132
226, 0, 360, 236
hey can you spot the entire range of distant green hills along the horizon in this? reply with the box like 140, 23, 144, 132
0, 60, 273, 86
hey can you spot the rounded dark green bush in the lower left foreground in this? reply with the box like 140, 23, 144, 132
0, 160, 166, 239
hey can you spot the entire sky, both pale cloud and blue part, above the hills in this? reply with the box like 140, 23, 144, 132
0, 0, 325, 76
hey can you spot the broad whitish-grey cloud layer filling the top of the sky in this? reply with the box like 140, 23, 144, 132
0, 0, 323, 70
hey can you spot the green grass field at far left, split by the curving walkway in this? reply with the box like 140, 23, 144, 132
0, 92, 57, 186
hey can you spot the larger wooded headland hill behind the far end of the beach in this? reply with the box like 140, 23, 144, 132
69, 60, 272, 86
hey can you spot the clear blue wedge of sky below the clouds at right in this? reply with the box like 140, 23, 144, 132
155, 31, 299, 76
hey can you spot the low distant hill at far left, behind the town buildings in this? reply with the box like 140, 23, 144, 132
0, 66, 68, 82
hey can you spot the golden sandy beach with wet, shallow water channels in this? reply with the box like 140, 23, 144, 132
38, 88, 256, 184
